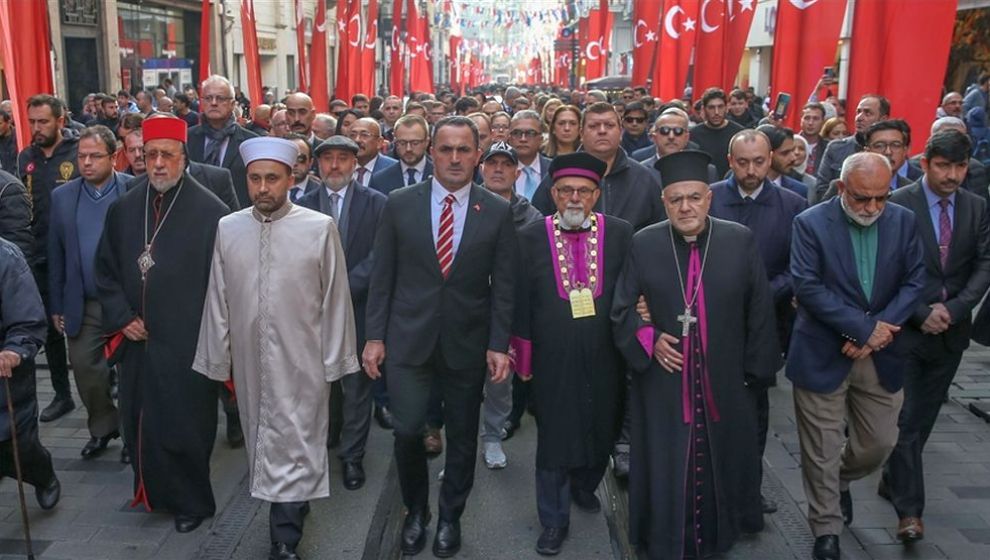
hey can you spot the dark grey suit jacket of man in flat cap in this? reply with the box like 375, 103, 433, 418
298, 181, 387, 351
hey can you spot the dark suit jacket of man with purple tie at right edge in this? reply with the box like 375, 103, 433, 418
890, 182, 990, 352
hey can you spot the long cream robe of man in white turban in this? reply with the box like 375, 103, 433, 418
193, 202, 359, 502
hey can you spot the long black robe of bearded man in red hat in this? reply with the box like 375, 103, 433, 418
96, 174, 229, 517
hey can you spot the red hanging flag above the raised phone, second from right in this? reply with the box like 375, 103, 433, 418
770, 0, 848, 130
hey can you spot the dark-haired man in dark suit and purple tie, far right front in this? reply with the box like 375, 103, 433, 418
880, 130, 990, 543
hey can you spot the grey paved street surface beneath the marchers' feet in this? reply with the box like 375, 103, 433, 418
0, 346, 990, 560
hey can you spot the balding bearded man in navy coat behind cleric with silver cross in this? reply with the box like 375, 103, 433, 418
709, 128, 808, 513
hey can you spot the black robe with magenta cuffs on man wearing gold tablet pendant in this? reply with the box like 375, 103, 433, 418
513, 214, 632, 469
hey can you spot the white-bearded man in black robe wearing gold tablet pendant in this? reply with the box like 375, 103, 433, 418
512, 152, 633, 555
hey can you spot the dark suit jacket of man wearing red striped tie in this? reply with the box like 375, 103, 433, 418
367, 181, 516, 369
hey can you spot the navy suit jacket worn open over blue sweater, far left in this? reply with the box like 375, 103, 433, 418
48, 173, 133, 336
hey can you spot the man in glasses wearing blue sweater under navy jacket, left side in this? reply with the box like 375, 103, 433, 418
48, 125, 131, 460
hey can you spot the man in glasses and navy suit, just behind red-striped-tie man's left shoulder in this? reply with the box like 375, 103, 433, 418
368, 115, 433, 194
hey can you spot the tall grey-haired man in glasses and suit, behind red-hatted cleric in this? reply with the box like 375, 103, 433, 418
186, 75, 258, 207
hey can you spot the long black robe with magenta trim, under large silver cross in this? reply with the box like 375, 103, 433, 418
612, 218, 780, 559
